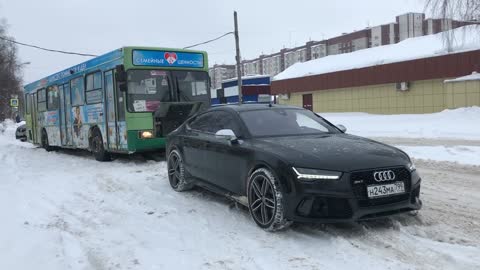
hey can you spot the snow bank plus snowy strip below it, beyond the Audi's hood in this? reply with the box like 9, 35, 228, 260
319, 107, 480, 165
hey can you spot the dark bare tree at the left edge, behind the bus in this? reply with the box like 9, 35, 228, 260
0, 20, 22, 121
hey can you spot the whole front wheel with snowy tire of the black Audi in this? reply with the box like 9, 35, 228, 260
247, 168, 292, 231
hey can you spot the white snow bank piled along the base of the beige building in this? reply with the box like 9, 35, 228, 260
319, 107, 480, 140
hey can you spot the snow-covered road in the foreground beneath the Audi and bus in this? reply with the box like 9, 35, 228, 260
0, 121, 480, 270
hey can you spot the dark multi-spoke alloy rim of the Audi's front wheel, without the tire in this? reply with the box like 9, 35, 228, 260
248, 175, 277, 226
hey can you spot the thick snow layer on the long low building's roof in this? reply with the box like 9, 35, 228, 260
273, 25, 480, 80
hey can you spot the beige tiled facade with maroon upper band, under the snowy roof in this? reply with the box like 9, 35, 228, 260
272, 50, 480, 114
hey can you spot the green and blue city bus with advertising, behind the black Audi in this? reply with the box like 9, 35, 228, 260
24, 47, 211, 161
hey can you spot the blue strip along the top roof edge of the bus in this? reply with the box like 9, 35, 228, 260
24, 46, 206, 93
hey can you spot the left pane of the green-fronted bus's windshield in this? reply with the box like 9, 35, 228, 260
127, 70, 174, 112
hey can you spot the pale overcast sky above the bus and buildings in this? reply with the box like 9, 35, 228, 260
0, 0, 424, 83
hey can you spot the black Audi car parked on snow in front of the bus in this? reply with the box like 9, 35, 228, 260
167, 104, 422, 231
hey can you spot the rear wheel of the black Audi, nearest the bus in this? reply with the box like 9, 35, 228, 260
167, 149, 193, 192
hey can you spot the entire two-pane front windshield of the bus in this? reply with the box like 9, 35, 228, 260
127, 70, 209, 112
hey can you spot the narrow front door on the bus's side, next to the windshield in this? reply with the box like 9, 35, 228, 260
104, 70, 120, 150
